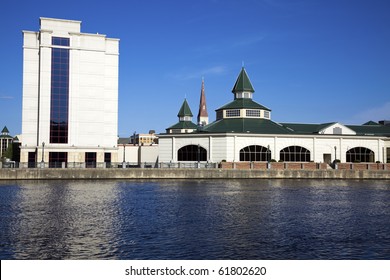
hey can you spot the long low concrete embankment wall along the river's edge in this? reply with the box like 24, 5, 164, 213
0, 168, 390, 180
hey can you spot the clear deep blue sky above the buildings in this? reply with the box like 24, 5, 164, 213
0, 0, 390, 137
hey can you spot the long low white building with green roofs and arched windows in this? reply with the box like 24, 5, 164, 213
159, 68, 390, 163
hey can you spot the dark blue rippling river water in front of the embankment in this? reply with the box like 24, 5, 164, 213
0, 180, 390, 259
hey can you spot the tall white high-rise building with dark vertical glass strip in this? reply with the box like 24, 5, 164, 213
20, 18, 119, 166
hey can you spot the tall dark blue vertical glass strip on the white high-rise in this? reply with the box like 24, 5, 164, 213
50, 37, 69, 144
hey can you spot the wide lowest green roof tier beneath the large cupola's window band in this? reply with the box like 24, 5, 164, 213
200, 118, 291, 134
